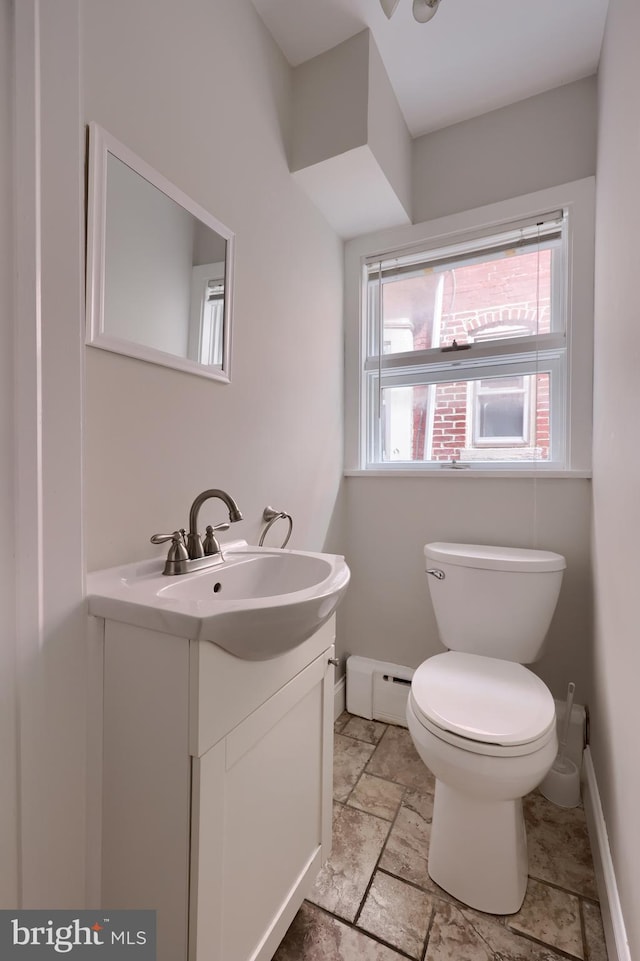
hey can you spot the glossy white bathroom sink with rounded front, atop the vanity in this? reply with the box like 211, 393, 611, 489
87, 541, 350, 660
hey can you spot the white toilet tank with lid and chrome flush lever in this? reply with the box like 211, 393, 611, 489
424, 543, 566, 664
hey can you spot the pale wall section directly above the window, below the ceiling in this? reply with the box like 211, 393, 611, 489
413, 77, 597, 222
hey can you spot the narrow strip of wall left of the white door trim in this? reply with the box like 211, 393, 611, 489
0, 0, 18, 908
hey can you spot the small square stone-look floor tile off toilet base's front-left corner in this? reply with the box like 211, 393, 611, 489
357, 871, 433, 961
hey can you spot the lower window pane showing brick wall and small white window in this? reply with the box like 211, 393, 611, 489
380, 372, 551, 463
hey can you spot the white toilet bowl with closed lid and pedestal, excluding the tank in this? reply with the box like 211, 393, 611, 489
407, 652, 558, 914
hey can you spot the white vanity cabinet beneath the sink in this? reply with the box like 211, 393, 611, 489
99, 617, 335, 961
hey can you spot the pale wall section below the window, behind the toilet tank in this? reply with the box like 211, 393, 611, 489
340, 474, 593, 703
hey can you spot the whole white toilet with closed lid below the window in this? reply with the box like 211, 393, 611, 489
407, 543, 566, 914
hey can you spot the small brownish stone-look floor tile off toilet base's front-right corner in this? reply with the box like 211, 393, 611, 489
507, 878, 584, 959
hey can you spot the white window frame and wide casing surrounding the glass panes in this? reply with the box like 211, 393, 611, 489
345, 177, 595, 476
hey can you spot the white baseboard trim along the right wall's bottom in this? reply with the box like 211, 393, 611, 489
582, 746, 631, 961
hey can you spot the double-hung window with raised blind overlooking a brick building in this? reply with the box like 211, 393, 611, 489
361, 210, 568, 470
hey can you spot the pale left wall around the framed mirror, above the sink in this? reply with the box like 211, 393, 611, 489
83, 0, 343, 569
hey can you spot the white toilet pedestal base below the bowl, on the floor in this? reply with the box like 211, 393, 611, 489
428, 779, 528, 914
